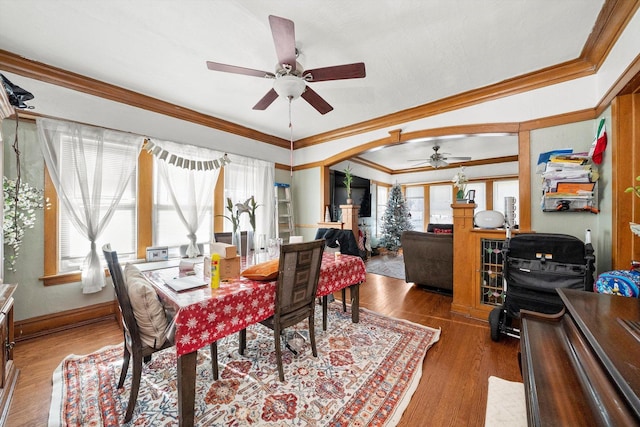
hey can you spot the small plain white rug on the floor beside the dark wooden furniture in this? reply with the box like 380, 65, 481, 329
484, 377, 527, 427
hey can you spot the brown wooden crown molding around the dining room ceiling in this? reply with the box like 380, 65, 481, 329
0, 0, 640, 153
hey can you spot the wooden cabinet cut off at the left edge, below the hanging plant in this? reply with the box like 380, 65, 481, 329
0, 284, 18, 425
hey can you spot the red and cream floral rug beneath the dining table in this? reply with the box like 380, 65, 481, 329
49, 303, 440, 426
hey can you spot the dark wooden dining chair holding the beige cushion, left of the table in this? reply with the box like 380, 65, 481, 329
102, 244, 218, 423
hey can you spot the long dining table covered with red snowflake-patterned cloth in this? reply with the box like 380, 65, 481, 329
141, 253, 366, 426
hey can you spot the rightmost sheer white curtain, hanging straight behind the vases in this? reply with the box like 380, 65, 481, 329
224, 154, 276, 238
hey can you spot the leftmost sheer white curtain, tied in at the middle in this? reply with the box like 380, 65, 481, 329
36, 118, 144, 294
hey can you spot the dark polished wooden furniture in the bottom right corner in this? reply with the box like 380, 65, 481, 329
520, 289, 640, 426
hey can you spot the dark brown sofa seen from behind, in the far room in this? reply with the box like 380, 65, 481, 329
400, 224, 453, 293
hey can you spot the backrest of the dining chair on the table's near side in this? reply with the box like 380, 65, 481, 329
275, 239, 325, 316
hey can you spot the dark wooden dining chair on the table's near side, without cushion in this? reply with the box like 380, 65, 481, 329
240, 240, 325, 381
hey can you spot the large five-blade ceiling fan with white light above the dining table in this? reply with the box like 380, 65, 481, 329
207, 15, 365, 114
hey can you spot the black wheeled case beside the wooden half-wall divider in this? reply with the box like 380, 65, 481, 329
489, 233, 595, 341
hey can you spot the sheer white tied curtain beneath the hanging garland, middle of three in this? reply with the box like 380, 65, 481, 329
153, 139, 224, 258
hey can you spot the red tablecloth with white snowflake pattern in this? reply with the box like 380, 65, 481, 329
145, 253, 366, 356
